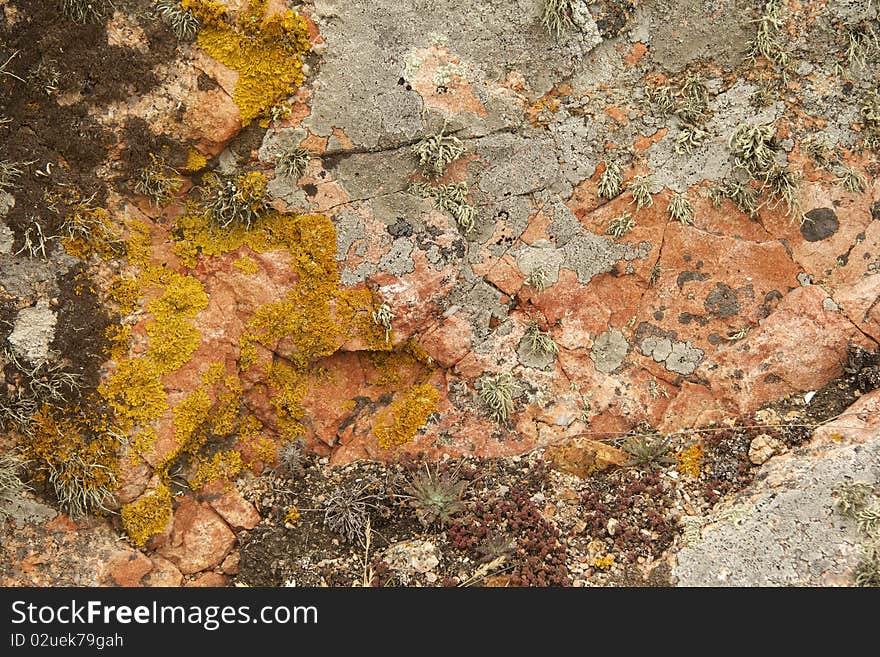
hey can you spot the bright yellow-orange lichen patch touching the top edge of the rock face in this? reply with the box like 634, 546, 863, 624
182, 0, 309, 125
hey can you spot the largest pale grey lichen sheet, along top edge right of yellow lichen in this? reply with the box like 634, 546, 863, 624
304, 0, 601, 149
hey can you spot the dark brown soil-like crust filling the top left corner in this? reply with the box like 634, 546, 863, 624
0, 0, 184, 238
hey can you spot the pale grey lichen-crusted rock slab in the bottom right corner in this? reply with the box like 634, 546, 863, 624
673, 437, 880, 586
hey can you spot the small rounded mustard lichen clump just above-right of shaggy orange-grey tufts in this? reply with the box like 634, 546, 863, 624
99, 358, 168, 430
